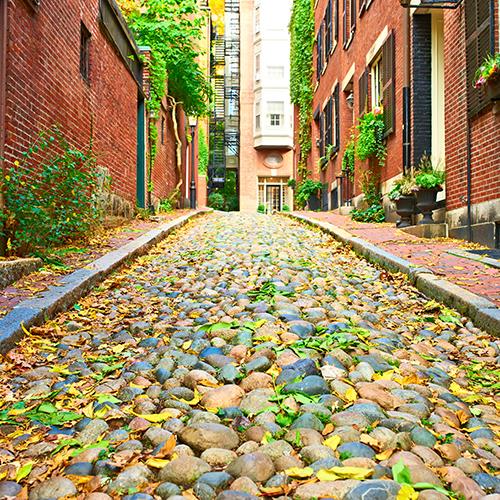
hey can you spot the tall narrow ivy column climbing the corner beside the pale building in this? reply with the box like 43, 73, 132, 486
289, 0, 314, 177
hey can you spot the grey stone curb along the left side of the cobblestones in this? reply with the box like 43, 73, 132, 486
0, 210, 210, 354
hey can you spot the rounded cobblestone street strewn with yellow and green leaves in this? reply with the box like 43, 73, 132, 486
0, 213, 500, 500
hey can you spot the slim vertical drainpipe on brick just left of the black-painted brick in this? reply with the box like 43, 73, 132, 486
403, 4, 411, 174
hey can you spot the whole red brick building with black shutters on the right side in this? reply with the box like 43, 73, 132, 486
308, 0, 500, 245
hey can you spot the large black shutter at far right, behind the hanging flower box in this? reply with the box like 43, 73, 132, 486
465, 0, 494, 116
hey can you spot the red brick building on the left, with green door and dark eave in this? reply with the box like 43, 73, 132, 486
0, 0, 186, 215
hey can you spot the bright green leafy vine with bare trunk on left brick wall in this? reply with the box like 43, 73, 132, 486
118, 0, 211, 200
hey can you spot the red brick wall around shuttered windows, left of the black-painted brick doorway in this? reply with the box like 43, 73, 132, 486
309, 0, 403, 194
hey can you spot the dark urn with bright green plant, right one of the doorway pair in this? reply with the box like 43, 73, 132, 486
415, 155, 445, 224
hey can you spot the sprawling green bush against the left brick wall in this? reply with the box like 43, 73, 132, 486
1, 128, 102, 254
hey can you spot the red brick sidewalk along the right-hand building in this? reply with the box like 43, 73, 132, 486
300, 212, 500, 306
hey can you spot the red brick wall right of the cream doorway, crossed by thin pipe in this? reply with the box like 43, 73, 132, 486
444, 0, 500, 210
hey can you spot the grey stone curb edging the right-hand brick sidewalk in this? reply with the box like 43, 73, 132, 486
280, 213, 500, 337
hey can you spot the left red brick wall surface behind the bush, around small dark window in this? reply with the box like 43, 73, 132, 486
5, 0, 138, 205
